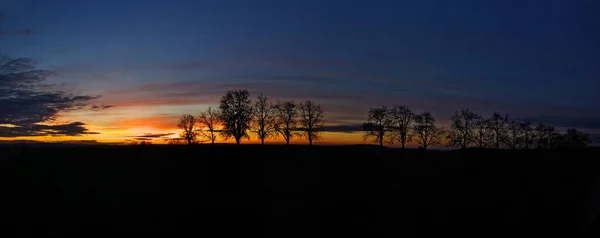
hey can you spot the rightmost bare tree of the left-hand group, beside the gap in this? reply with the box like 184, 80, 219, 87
300, 100, 323, 146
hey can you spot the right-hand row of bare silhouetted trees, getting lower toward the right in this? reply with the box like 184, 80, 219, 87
363, 106, 590, 149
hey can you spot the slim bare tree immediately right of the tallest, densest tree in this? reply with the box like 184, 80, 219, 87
254, 94, 275, 145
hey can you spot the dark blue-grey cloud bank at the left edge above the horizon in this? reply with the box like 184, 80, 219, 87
0, 56, 100, 137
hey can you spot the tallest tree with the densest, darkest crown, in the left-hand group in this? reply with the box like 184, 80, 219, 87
219, 89, 252, 145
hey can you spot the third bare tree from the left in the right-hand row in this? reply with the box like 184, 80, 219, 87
413, 112, 444, 150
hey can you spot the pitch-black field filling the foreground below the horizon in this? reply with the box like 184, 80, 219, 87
0, 145, 600, 237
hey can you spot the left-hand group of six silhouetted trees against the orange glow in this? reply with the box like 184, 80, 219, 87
178, 90, 324, 145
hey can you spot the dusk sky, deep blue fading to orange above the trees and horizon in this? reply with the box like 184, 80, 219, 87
0, 0, 600, 144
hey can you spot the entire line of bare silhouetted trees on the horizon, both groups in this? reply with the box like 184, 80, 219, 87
169, 90, 591, 149
